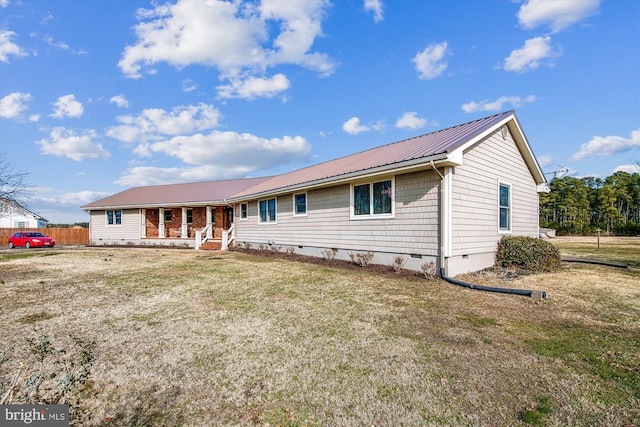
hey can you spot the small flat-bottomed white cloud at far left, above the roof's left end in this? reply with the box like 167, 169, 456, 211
36, 127, 111, 162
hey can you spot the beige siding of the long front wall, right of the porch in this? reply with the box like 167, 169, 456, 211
236, 171, 440, 256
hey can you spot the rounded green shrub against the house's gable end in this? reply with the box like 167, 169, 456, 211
496, 236, 560, 271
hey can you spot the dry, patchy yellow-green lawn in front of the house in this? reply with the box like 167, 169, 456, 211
0, 241, 640, 426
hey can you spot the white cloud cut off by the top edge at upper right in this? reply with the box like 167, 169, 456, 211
518, 0, 601, 33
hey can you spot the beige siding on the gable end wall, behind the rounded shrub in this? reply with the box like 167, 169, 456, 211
451, 131, 538, 256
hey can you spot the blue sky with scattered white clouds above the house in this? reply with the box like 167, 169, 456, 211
0, 0, 640, 223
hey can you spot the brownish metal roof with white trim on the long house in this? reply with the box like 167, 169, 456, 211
82, 111, 546, 210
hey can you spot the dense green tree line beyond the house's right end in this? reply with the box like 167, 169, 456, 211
540, 171, 640, 236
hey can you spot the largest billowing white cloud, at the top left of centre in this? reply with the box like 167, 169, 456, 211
118, 0, 336, 95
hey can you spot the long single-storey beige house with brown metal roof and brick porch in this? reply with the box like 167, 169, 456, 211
82, 111, 548, 276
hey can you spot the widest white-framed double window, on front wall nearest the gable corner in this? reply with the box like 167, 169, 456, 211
352, 179, 394, 218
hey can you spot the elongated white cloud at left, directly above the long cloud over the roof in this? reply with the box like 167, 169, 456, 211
107, 103, 220, 143
